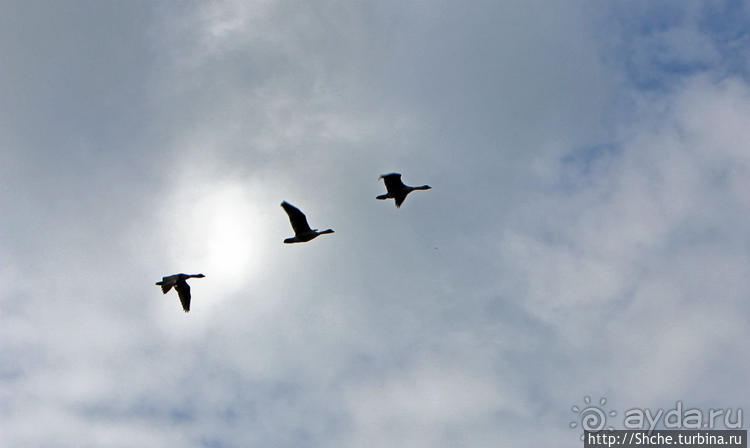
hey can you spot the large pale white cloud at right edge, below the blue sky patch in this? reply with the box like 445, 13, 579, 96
501, 73, 750, 416
